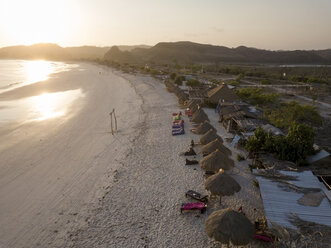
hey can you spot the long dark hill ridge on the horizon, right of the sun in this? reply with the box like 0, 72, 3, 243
104, 41, 331, 64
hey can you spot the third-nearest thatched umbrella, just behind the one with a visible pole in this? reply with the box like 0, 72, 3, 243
200, 149, 234, 172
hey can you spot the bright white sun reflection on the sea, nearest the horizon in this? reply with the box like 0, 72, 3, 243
26, 60, 55, 83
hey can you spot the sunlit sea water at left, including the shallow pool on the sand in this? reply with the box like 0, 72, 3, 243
0, 60, 82, 125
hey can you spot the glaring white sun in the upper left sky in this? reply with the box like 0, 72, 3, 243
1, 0, 75, 45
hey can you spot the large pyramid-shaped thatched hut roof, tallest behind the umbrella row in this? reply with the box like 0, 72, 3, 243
207, 83, 240, 104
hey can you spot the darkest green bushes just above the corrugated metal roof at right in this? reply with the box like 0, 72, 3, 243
245, 123, 315, 166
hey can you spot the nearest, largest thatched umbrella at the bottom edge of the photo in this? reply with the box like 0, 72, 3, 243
205, 208, 255, 245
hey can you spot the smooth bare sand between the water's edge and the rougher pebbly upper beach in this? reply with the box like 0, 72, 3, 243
0, 64, 141, 247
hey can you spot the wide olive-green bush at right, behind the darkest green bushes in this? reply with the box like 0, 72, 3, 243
265, 101, 322, 129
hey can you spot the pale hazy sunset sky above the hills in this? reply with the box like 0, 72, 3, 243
0, 0, 331, 50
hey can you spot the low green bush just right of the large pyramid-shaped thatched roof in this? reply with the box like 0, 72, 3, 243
236, 88, 279, 105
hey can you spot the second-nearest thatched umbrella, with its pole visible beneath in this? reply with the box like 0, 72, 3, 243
205, 170, 241, 203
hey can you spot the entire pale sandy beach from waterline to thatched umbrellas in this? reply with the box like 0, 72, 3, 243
0, 65, 264, 247
